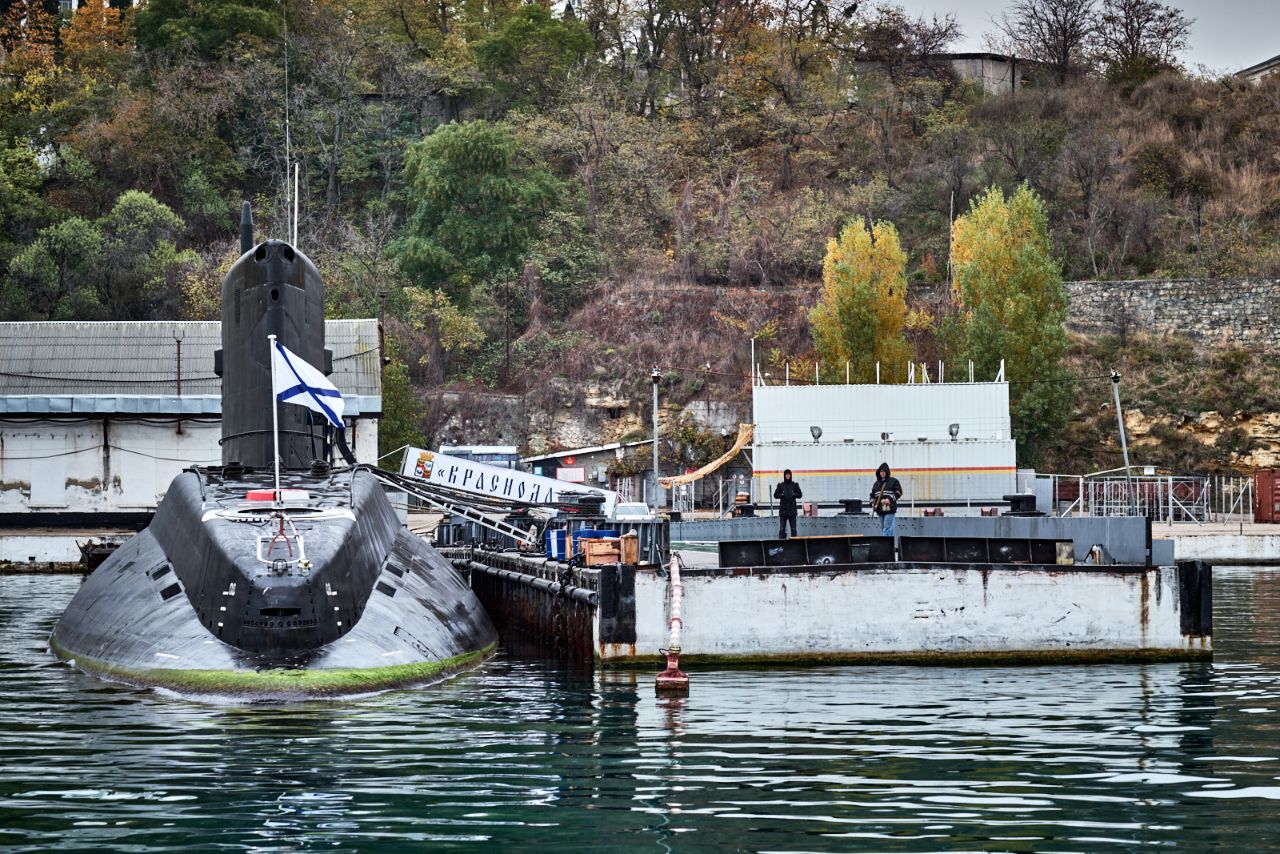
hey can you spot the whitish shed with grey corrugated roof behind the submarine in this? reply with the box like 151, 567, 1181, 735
0, 320, 383, 526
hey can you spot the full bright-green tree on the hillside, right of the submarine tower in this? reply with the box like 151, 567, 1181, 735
392, 120, 556, 309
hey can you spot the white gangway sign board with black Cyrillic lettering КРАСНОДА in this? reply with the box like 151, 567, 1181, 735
401, 448, 618, 516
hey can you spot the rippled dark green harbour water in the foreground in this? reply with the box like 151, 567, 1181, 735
0, 568, 1280, 851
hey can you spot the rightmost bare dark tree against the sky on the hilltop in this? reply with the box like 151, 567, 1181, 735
1097, 0, 1193, 85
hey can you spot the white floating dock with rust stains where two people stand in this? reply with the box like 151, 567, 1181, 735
448, 516, 1212, 667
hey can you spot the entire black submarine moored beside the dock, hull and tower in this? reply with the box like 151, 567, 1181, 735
50, 202, 497, 699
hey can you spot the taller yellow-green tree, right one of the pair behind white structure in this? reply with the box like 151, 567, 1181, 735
952, 184, 1071, 465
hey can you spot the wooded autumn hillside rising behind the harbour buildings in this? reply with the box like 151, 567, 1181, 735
0, 0, 1280, 469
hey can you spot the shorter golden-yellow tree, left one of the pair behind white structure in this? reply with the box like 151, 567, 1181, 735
809, 223, 910, 383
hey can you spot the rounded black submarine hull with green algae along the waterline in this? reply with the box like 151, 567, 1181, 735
51, 469, 497, 699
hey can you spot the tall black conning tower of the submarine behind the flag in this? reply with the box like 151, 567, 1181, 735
214, 202, 333, 469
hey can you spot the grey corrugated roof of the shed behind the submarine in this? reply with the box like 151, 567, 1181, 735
0, 320, 383, 399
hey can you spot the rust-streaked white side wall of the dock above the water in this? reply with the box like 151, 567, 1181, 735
616, 563, 1211, 661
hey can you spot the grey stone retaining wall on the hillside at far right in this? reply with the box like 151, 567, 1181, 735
1066, 279, 1280, 352
